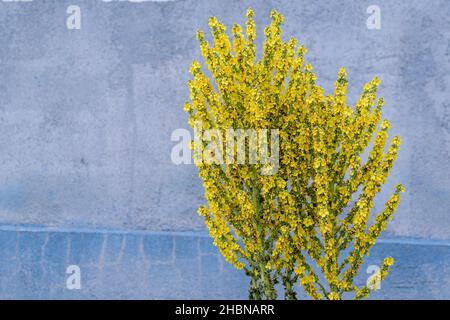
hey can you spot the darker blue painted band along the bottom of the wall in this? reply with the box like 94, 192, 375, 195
0, 226, 450, 299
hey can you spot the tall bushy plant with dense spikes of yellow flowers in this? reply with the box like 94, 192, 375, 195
184, 9, 403, 300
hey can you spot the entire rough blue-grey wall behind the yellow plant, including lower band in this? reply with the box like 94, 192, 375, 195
0, 0, 450, 298
